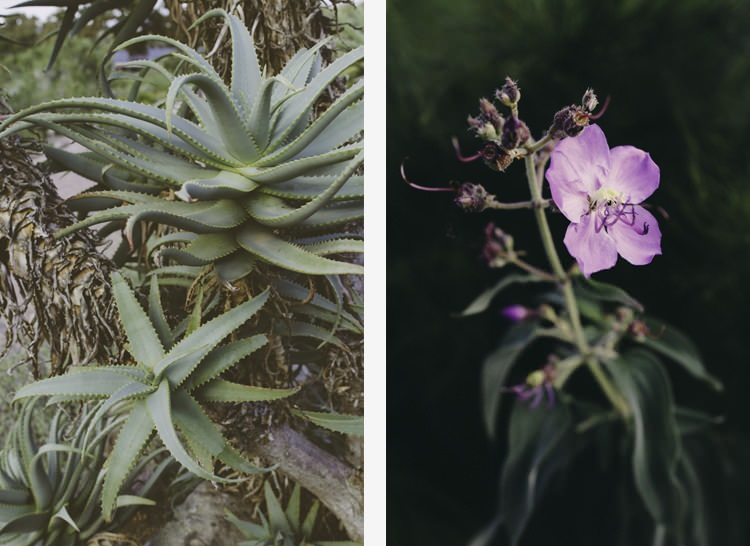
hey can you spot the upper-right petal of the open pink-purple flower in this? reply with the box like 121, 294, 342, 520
604, 146, 659, 204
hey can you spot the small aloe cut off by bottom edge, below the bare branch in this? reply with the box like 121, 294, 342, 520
227, 481, 361, 546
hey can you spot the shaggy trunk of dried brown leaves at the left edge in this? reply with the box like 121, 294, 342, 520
0, 137, 118, 378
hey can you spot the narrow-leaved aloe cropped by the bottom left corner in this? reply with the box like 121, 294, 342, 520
0, 400, 173, 546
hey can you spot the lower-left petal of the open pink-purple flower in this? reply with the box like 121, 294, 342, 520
563, 216, 617, 277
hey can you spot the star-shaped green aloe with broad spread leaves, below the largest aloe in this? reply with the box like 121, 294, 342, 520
16, 272, 298, 517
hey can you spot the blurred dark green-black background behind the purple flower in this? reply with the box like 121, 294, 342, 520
385, 0, 750, 546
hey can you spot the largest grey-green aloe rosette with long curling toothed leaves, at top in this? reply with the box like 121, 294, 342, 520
0, 10, 364, 281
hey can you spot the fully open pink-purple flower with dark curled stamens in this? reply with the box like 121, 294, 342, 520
547, 125, 661, 277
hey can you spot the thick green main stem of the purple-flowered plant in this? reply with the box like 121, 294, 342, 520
524, 154, 630, 417
